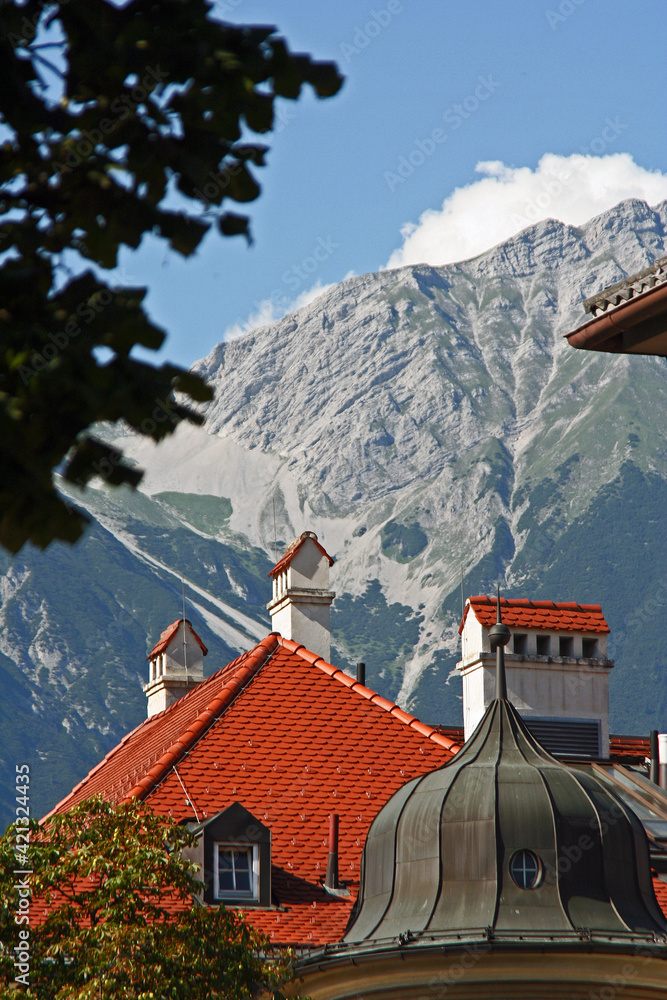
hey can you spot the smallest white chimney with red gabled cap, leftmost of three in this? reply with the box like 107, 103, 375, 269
144, 618, 208, 719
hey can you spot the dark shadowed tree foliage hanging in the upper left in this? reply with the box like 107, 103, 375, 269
0, 0, 342, 552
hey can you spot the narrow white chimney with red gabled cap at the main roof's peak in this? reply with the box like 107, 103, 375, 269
267, 531, 336, 663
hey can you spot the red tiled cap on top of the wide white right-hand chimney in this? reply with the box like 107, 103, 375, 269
459, 595, 609, 635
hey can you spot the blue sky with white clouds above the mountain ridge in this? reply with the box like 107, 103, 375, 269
122, 0, 667, 364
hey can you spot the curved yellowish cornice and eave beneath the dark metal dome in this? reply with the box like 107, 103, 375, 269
294, 928, 665, 1000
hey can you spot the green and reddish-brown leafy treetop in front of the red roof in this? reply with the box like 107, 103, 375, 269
0, 797, 292, 1000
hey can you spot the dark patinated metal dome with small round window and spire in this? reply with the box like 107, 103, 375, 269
344, 692, 667, 946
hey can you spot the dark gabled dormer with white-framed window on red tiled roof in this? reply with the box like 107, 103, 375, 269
199, 802, 271, 907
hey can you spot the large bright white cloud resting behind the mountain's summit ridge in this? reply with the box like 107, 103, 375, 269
387, 153, 667, 267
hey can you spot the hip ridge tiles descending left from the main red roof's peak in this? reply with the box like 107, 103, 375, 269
121, 632, 278, 802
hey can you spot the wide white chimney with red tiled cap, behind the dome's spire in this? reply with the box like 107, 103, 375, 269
456, 596, 614, 757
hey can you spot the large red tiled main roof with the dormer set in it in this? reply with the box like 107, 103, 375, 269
45, 633, 458, 946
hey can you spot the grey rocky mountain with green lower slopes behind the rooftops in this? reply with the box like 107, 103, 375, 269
0, 201, 667, 828
